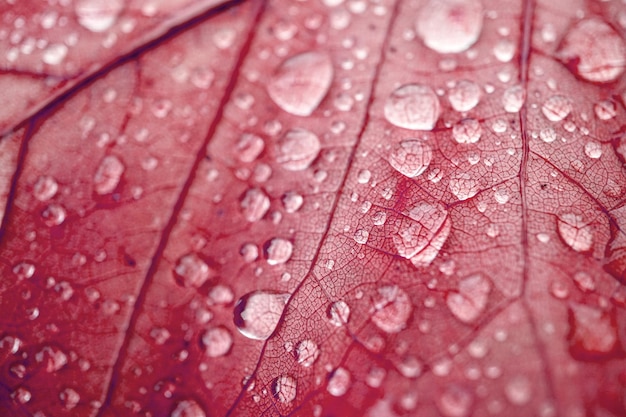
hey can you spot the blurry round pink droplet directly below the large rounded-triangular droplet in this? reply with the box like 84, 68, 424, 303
276, 129, 321, 171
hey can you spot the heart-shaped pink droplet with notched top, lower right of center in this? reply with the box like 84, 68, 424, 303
446, 274, 491, 323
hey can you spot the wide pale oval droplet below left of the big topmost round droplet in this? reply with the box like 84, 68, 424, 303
384, 84, 441, 130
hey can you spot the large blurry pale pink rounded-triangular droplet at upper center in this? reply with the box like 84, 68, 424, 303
267, 52, 333, 116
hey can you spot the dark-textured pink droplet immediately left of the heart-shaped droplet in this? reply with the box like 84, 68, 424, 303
370, 285, 413, 333
